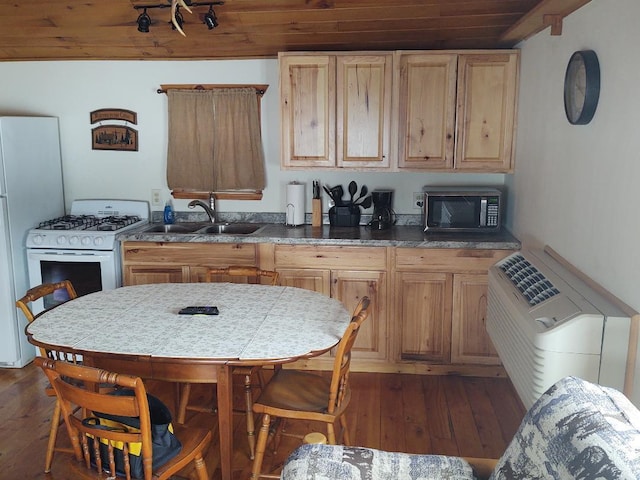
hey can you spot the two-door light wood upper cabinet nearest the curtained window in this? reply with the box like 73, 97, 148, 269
279, 52, 393, 169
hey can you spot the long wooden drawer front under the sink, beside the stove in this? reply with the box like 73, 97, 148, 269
122, 242, 257, 266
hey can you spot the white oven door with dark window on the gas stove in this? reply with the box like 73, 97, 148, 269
27, 248, 121, 314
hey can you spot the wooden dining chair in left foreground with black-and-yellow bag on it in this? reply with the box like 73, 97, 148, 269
35, 357, 211, 480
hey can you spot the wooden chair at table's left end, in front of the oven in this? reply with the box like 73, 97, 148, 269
16, 280, 78, 473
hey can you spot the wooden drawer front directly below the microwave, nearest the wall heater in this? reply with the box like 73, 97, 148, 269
395, 248, 512, 273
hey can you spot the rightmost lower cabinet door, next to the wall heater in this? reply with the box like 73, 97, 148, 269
451, 274, 500, 365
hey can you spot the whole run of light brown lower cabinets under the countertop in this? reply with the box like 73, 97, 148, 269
122, 241, 511, 376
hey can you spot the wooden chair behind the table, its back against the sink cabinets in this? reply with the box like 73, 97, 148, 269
177, 265, 280, 460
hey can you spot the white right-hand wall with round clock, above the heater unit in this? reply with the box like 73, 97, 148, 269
508, 0, 640, 310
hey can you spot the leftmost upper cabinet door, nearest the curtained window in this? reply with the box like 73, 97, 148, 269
279, 55, 336, 167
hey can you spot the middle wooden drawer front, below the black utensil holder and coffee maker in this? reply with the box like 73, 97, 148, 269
275, 245, 387, 270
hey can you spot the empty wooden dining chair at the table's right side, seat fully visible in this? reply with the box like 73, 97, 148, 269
251, 297, 371, 480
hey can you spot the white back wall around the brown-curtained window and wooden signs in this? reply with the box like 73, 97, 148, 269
0, 59, 505, 214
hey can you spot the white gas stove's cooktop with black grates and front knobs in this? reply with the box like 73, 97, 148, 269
26, 200, 149, 250
